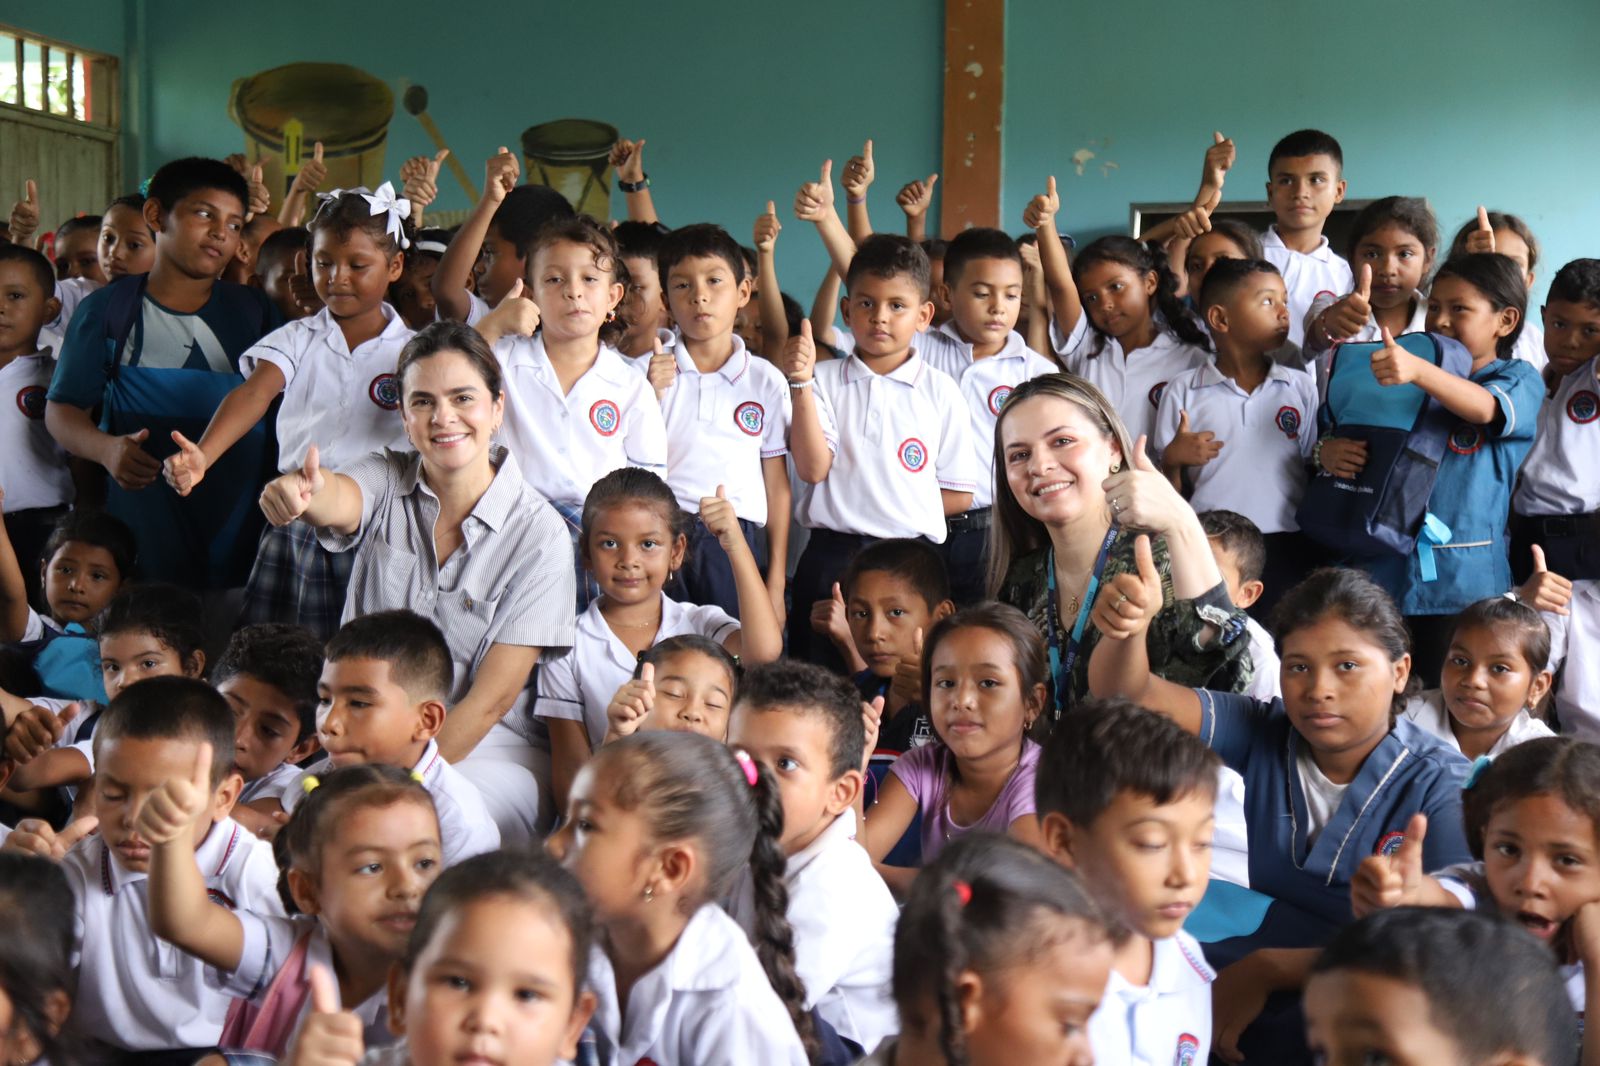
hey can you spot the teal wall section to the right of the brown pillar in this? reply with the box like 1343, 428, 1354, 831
1002, 0, 1600, 296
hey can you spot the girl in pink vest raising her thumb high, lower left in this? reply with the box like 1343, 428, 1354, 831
144, 758, 440, 1056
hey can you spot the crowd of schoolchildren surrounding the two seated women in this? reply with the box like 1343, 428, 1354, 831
0, 116, 1600, 1066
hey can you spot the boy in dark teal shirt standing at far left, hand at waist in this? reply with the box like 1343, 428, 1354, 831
45, 158, 282, 589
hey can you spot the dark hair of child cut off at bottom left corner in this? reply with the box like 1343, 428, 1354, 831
0, 852, 77, 1063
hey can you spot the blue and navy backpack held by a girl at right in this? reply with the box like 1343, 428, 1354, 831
1296, 333, 1472, 579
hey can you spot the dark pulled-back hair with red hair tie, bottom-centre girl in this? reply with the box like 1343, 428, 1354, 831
893, 831, 1110, 1066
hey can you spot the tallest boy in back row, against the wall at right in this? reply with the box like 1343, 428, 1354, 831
1261, 130, 1355, 346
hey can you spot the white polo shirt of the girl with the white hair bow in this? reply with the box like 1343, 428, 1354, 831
238, 304, 416, 472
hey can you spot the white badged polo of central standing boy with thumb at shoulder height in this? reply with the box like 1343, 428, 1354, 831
795, 349, 984, 544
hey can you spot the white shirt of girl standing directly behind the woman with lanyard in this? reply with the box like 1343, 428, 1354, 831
1050, 312, 1211, 445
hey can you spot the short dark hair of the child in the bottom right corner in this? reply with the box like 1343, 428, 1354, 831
1310, 908, 1578, 1066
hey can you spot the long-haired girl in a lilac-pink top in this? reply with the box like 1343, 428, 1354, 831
862, 603, 1048, 893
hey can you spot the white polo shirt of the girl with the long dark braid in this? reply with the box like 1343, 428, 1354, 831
589, 903, 808, 1066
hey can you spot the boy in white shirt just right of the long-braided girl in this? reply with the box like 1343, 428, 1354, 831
728, 661, 899, 1061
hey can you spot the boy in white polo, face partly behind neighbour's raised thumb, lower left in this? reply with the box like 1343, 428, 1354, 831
62, 677, 283, 1061
